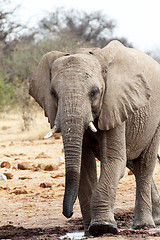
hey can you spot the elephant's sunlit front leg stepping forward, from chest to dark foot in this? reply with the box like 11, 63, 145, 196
89, 124, 126, 236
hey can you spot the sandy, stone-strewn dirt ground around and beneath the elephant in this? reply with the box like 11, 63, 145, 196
0, 111, 160, 240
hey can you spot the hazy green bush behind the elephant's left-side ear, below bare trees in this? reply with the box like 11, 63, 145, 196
0, 33, 89, 129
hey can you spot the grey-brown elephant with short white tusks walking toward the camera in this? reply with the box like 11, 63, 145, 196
29, 40, 160, 236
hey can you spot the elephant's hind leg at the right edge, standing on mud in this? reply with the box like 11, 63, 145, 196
133, 125, 159, 229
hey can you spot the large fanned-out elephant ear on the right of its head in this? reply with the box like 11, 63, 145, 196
98, 41, 151, 130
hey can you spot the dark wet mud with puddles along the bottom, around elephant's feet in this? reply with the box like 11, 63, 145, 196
0, 211, 160, 240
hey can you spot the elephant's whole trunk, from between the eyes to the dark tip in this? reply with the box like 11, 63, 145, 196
55, 91, 93, 218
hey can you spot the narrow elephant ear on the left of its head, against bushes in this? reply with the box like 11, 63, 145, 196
29, 51, 66, 128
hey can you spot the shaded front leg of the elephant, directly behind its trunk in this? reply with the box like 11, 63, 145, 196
78, 147, 97, 236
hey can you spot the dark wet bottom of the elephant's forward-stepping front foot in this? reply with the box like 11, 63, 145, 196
89, 222, 118, 237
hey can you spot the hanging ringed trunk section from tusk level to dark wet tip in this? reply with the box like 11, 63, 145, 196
61, 115, 84, 218
